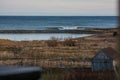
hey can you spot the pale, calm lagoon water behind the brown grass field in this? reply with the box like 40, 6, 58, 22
0, 33, 93, 41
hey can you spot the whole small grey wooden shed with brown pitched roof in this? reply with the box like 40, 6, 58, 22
92, 47, 118, 71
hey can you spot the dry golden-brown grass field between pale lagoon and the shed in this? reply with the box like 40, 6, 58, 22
0, 28, 120, 80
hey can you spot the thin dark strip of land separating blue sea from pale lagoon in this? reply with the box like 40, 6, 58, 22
0, 28, 117, 34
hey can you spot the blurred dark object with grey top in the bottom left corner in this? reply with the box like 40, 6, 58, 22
0, 66, 42, 80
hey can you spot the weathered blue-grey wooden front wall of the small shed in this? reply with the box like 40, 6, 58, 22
92, 51, 113, 71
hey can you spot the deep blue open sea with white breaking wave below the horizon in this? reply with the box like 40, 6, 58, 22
0, 16, 117, 30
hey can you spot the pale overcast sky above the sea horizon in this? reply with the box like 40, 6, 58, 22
0, 0, 117, 16
